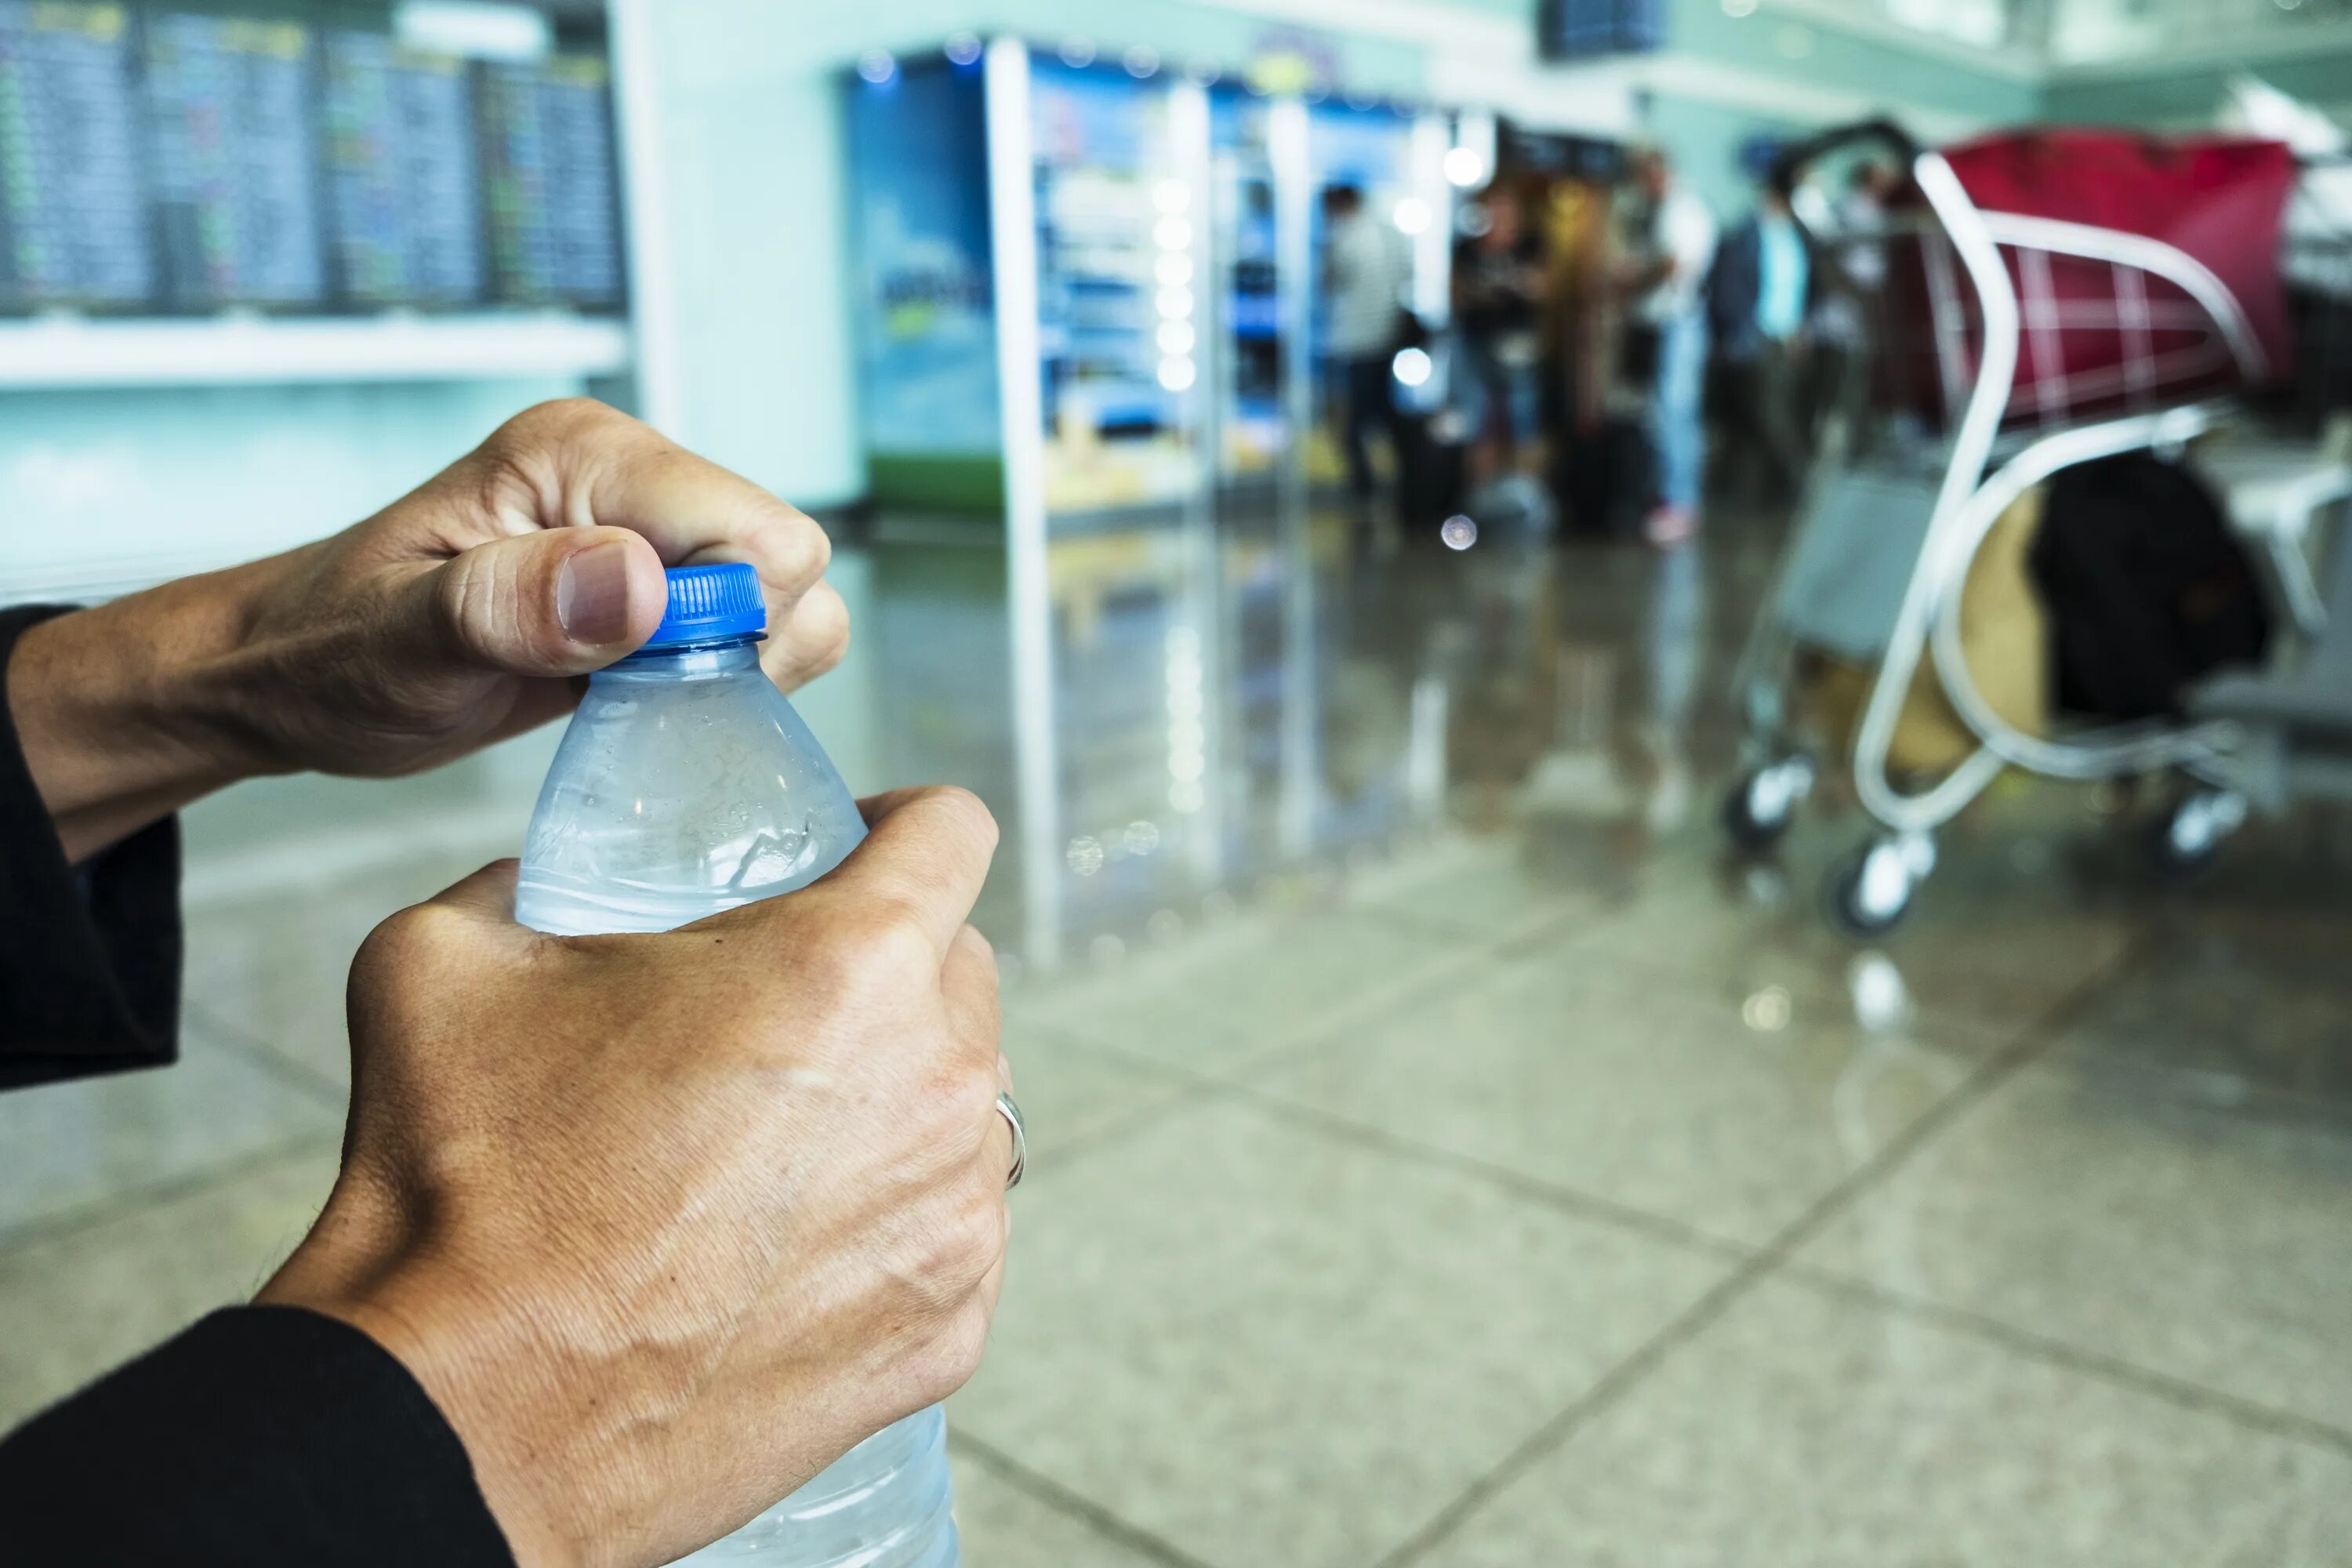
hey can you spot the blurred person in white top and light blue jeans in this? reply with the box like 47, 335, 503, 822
1618, 148, 1715, 550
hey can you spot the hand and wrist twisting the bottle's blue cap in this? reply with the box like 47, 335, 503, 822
7, 400, 849, 858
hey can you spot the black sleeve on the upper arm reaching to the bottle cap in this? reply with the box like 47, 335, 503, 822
0, 609, 179, 1088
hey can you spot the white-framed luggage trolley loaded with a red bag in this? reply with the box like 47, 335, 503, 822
1724, 120, 2352, 935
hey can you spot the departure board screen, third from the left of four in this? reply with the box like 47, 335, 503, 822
322, 31, 489, 306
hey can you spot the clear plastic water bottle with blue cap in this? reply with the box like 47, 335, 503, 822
515, 564, 962, 1568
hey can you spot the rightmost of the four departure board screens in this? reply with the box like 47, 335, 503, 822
480, 54, 626, 308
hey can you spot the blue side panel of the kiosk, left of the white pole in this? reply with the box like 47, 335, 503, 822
847, 61, 1002, 484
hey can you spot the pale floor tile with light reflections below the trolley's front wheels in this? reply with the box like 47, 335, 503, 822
1256, 949, 1992, 1246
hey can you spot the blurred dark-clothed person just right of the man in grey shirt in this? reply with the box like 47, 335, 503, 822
1454, 186, 1543, 492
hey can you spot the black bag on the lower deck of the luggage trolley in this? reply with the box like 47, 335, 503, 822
2030, 452, 2270, 722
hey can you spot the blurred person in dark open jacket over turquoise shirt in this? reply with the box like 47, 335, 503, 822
1708, 179, 1813, 508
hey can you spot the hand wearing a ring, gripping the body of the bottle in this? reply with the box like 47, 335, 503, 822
261, 789, 1011, 1568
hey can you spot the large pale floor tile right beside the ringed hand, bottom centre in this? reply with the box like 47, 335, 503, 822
950, 1102, 1726, 1568
